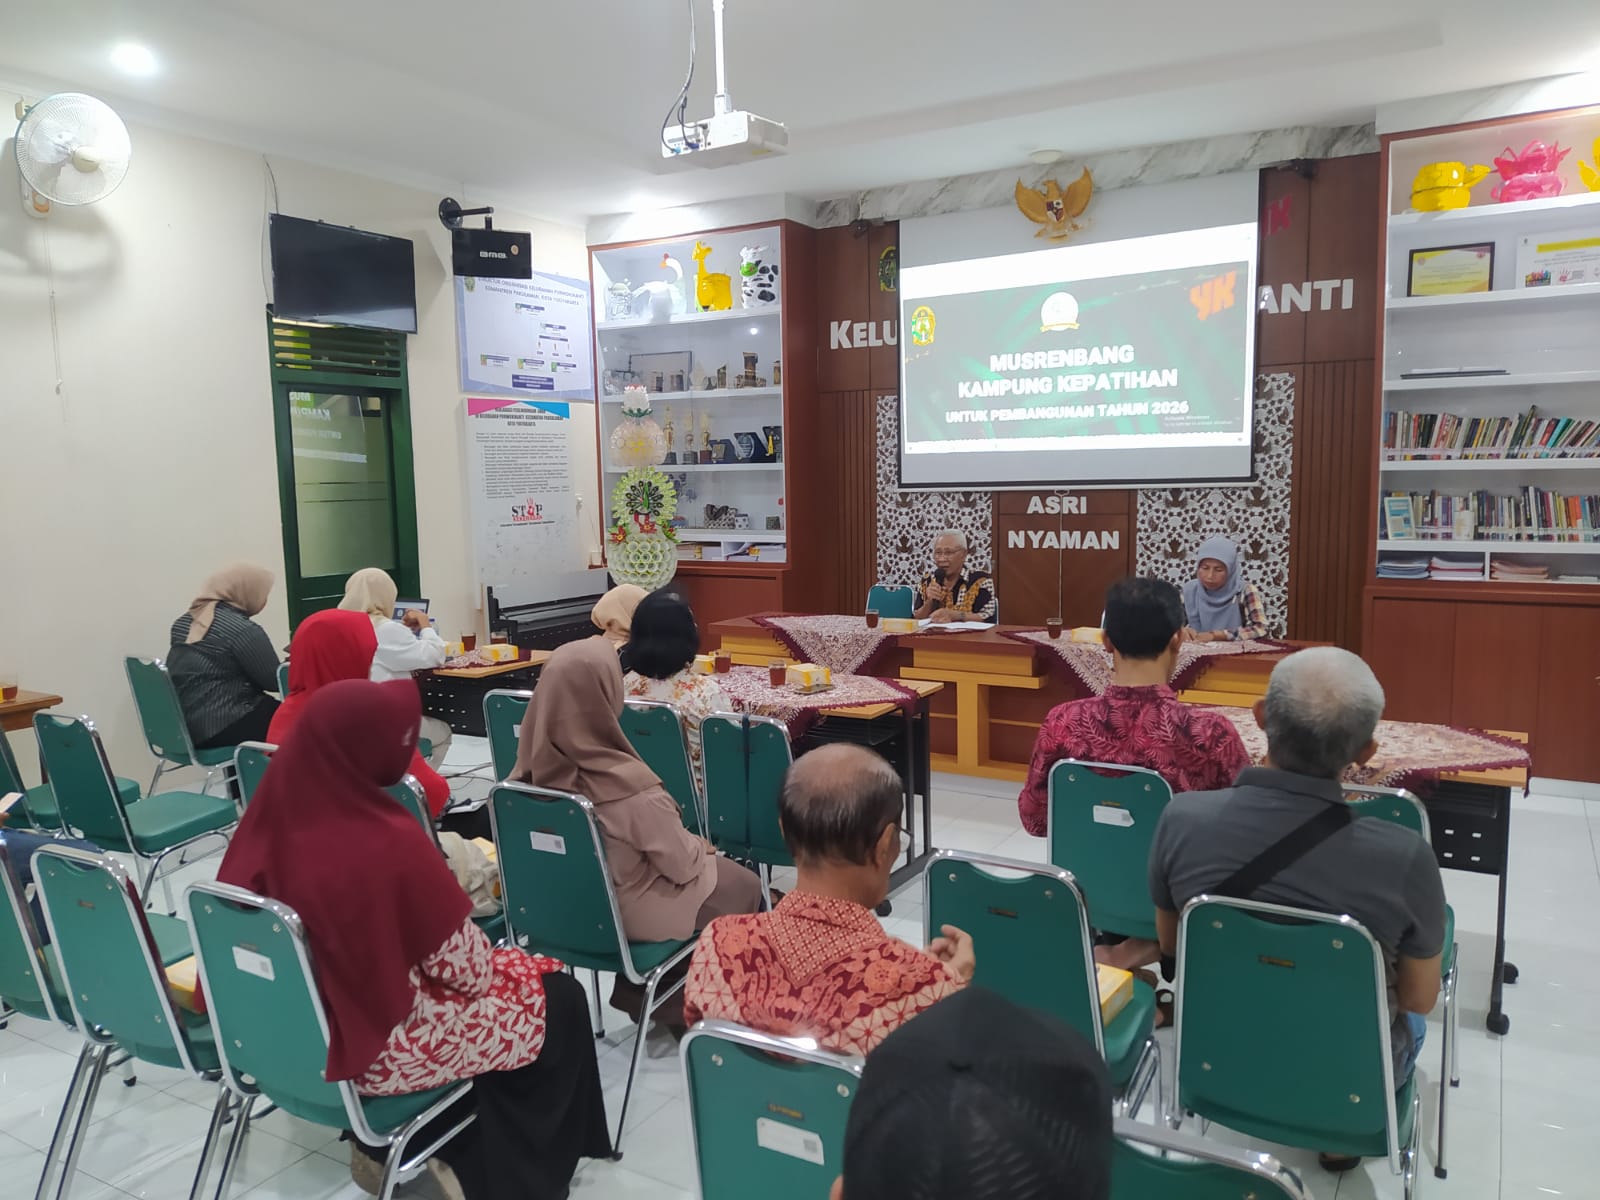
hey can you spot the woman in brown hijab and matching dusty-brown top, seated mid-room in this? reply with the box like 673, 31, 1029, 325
512, 637, 762, 1021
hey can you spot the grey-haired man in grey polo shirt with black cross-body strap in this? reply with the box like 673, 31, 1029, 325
1150, 646, 1445, 1086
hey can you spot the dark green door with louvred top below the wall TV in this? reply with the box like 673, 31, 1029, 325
270, 322, 421, 627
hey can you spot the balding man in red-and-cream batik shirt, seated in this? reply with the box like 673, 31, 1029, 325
683, 744, 974, 1054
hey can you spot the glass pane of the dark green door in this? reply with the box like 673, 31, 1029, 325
290, 392, 395, 578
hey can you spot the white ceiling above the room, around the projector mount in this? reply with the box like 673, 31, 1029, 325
0, 0, 1600, 219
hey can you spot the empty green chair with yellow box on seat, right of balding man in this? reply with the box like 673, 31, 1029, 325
922, 850, 1165, 1115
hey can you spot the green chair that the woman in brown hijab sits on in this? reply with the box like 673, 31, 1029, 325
490, 784, 694, 1158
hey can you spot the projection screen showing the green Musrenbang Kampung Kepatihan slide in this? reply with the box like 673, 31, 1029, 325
899, 189, 1256, 488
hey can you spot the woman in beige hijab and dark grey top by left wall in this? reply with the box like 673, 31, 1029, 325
166, 563, 278, 749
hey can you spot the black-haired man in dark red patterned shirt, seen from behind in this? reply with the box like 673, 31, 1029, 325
1016, 579, 1250, 968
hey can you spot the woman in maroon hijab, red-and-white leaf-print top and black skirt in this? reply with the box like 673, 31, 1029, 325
218, 681, 611, 1200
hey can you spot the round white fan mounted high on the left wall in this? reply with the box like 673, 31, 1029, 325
16, 91, 133, 216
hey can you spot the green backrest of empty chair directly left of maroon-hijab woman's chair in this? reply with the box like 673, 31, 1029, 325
34, 845, 201, 1074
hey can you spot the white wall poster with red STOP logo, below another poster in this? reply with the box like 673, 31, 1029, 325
466, 397, 590, 600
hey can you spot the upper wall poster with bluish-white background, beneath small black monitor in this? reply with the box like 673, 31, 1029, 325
456, 272, 594, 400
